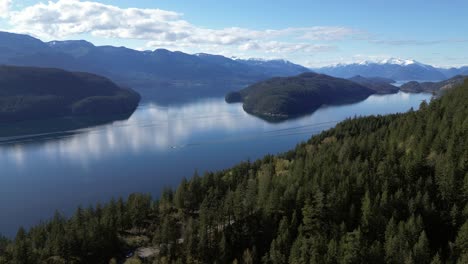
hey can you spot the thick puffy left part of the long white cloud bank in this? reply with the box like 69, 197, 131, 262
10, 0, 181, 39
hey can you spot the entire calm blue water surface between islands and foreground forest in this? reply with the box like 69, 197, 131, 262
0, 93, 431, 236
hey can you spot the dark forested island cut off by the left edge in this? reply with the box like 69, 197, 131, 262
0, 66, 140, 124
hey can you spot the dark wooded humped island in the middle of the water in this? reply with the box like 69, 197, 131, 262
225, 72, 376, 121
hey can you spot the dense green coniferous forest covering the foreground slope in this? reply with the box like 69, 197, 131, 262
0, 82, 468, 264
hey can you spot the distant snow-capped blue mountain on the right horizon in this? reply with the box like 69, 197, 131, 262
315, 58, 447, 81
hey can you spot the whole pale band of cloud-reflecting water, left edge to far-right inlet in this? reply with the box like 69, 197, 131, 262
0, 93, 427, 167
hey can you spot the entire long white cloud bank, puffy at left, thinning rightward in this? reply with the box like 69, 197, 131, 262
7, 0, 360, 53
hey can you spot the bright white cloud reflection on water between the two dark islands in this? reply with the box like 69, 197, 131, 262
0, 99, 256, 165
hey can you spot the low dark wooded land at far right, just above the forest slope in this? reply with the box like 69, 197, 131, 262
400, 75, 468, 94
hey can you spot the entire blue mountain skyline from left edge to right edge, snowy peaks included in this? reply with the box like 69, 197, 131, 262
0, 32, 468, 100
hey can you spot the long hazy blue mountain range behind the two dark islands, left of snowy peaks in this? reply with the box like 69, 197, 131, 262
0, 32, 310, 100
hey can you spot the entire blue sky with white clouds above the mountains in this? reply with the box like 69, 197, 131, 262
0, 0, 468, 67
